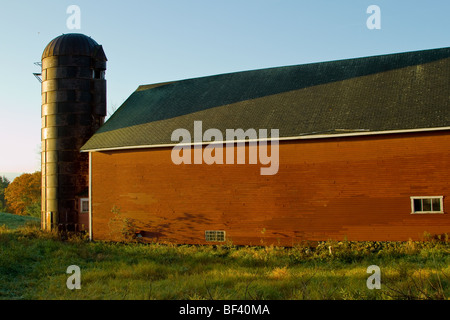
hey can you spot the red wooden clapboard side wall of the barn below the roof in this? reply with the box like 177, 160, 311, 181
92, 132, 450, 245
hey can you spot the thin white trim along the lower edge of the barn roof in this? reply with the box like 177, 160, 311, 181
81, 127, 450, 152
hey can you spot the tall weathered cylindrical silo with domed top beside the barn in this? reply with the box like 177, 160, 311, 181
41, 33, 107, 231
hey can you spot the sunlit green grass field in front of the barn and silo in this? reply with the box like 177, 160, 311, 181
0, 214, 450, 300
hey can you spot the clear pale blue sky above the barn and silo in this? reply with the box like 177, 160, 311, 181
0, 0, 450, 180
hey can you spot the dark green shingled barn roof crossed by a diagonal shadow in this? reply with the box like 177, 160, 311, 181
82, 48, 450, 151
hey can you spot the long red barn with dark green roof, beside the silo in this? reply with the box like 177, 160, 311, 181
82, 48, 450, 246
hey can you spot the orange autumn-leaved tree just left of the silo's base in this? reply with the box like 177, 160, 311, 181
5, 171, 41, 217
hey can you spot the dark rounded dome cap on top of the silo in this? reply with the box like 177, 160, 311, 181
42, 33, 107, 61
